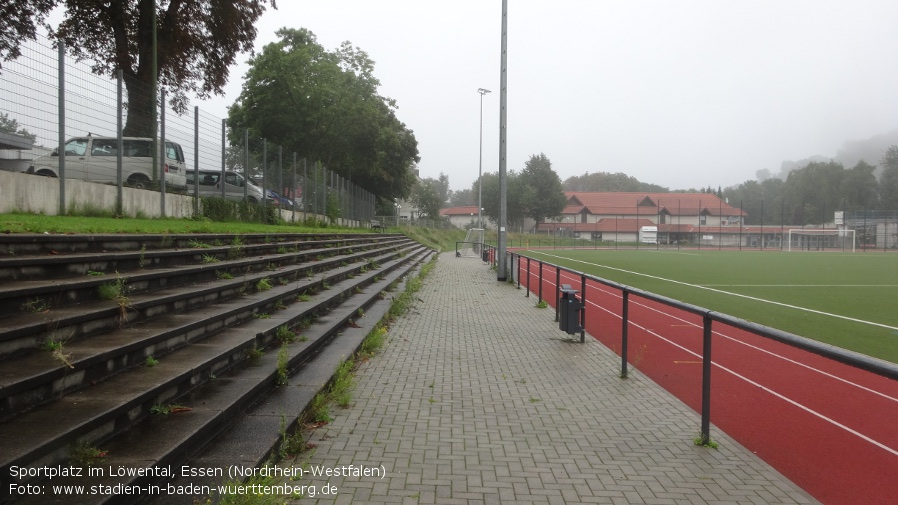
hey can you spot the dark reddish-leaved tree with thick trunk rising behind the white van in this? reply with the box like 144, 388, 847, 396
48, 0, 277, 136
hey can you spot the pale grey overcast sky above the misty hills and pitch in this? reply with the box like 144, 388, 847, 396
198, 0, 898, 193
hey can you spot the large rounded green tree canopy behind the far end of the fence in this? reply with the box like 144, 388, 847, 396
228, 28, 416, 200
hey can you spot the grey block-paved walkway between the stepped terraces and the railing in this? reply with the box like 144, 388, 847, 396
294, 254, 817, 505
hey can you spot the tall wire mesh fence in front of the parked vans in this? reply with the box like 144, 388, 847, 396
0, 34, 377, 226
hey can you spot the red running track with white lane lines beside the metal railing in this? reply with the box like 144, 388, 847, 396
520, 261, 898, 504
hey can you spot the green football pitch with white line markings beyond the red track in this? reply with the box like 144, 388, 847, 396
522, 249, 898, 363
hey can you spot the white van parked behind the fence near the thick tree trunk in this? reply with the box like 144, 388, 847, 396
27, 135, 187, 190
